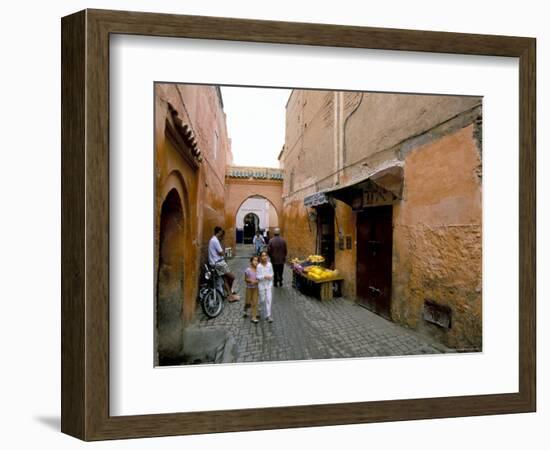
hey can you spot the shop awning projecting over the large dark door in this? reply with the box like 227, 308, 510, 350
324, 161, 403, 209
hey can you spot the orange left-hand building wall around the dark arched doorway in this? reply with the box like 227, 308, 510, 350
155, 83, 231, 323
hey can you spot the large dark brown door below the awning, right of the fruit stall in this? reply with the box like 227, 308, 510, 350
356, 206, 393, 319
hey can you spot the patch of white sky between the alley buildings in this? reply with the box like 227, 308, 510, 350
220, 86, 291, 167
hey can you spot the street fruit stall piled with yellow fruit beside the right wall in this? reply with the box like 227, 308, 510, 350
290, 255, 344, 301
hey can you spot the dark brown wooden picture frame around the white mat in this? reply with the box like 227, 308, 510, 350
61, 10, 536, 440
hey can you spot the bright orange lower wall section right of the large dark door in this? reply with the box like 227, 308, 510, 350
392, 125, 482, 350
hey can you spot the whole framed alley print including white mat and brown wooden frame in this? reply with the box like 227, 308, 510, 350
62, 10, 536, 440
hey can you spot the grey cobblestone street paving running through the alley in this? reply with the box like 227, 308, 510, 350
196, 247, 451, 362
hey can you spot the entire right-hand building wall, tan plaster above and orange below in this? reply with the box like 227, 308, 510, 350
280, 90, 482, 350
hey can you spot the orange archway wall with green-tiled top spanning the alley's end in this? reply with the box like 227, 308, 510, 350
225, 166, 284, 249
